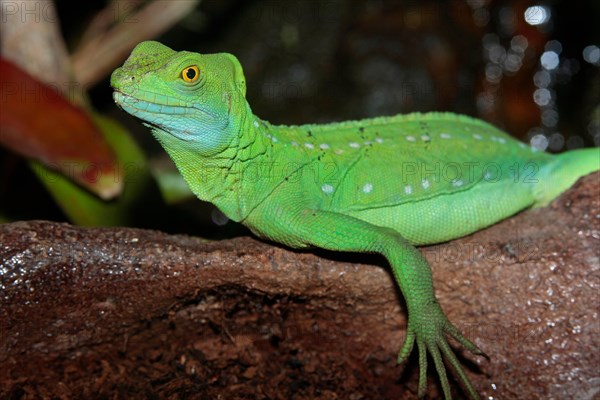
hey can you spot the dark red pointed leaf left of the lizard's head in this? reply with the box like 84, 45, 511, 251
0, 58, 122, 199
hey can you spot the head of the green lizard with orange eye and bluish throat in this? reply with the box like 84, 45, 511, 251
111, 41, 248, 154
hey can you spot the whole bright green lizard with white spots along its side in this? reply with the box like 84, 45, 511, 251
111, 42, 600, 399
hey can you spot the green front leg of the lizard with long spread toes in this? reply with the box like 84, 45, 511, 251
288, 209, 485, 399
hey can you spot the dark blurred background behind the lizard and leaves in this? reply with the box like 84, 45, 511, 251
0, 0, 600, 230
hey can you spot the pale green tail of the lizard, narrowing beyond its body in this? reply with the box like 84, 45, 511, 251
534, 147, 600, 207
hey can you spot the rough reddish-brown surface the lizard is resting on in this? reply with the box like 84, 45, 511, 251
0, 173, 600, 399
